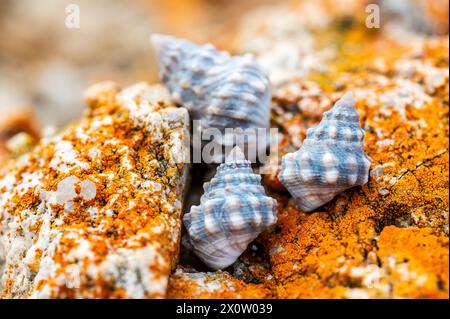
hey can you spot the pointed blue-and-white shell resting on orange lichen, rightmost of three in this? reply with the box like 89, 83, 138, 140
279, 93, 371, 212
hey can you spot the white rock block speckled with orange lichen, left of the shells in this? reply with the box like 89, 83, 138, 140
0, 82, 189, 298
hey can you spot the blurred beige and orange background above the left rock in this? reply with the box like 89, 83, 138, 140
0, 0, 284, 126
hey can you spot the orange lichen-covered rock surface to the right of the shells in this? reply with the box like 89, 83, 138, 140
171, 1, 449, 298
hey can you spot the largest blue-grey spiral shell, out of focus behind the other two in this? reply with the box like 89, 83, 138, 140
151, 35, 271, 162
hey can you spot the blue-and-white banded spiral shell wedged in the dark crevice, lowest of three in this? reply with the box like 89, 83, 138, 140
183, 147, 276, 269
